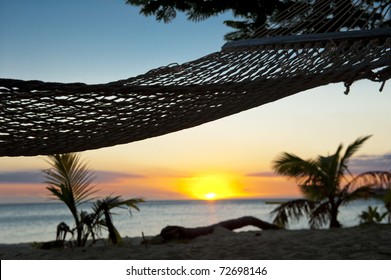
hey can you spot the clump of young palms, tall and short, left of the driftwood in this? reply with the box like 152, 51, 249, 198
44, 153, 144, 246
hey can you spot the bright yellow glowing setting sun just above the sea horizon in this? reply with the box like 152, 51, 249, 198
181, 174, 243, 200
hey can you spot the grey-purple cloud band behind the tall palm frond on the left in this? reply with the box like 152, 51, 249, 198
0, 170, 143, 184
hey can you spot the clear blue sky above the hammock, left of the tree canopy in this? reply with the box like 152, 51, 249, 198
0, 0, 229, 83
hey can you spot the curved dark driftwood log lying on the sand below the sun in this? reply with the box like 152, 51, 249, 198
160, 216, 280, 240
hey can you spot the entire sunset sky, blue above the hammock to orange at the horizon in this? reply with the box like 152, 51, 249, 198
0, 0, 391, 203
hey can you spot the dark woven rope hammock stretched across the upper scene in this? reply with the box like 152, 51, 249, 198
0, 0, 391, 156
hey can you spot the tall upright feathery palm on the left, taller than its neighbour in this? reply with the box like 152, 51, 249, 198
44, 153, 97, 246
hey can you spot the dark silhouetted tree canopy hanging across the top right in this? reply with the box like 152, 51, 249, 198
126, 0, 391, 41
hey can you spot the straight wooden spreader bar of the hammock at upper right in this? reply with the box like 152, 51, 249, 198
222, 28, 391, 49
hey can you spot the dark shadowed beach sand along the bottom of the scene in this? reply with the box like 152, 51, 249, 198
0, 225, 391, 260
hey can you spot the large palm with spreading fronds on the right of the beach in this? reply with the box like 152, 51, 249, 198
272, 136, 391, 228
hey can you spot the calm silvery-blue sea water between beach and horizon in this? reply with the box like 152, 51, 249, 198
0, 200, 384, 243
